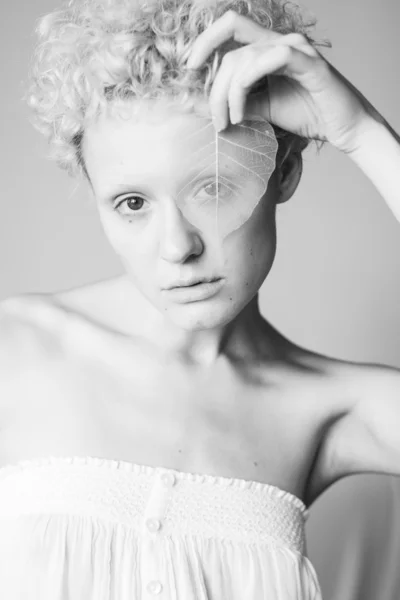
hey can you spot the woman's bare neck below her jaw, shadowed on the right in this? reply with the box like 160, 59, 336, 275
115, 276, 283, 366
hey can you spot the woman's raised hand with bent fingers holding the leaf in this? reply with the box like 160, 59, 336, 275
187, 11, 379, 152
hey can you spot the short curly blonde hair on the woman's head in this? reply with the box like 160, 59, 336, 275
27, 0, 330, 176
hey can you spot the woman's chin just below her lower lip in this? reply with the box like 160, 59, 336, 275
163, 299, 240, 331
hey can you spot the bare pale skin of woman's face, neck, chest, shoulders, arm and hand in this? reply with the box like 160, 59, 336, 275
0, 12, 400, 506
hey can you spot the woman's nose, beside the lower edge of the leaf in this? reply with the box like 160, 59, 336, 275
160, 202, 204, 263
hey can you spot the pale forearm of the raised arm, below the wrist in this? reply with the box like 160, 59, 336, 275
347, 117, 400, 221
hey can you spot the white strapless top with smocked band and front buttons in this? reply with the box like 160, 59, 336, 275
0, 456, 322, 600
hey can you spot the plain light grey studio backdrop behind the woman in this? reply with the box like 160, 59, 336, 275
0, 0, 400, 600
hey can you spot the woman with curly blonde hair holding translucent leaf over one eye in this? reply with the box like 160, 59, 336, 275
0, 0, 400, 600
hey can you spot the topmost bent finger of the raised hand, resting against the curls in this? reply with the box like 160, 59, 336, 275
187, 10, 282, 69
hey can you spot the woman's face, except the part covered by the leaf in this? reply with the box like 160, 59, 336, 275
82, 103, 278, 330
